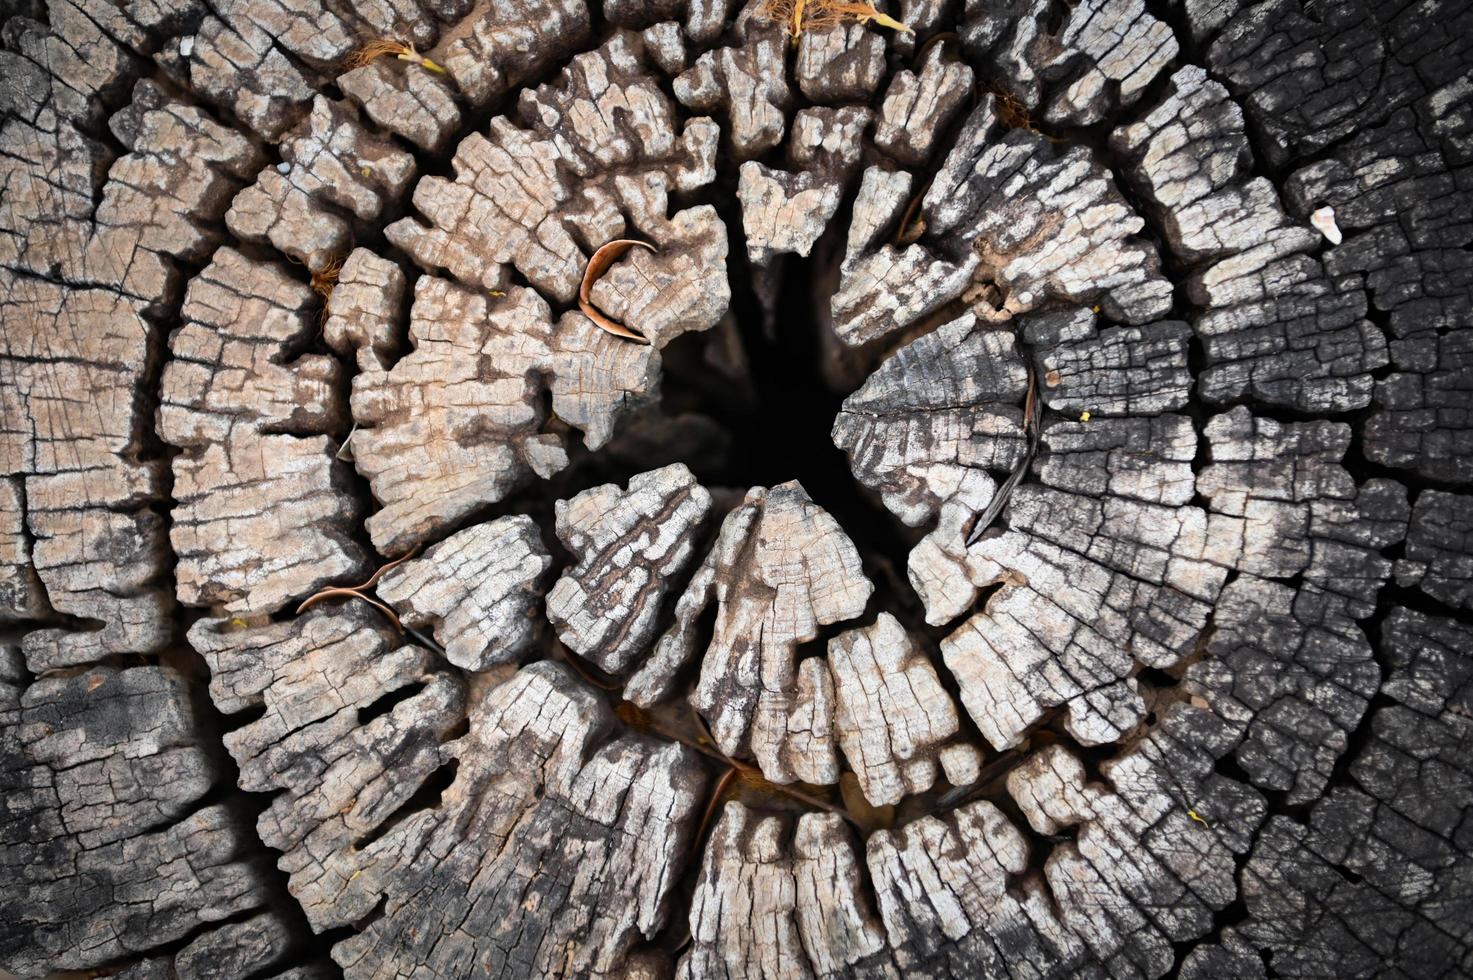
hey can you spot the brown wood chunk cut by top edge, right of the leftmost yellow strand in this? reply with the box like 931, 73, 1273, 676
437, 0, 589, 108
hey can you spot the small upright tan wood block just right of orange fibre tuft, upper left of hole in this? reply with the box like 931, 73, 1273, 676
323, 249, 405, 373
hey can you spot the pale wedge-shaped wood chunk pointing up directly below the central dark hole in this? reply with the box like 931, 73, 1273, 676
625, 482, 873, 784
